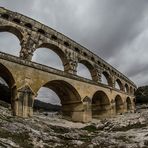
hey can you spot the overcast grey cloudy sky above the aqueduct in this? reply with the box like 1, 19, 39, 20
0, 0, 148, 102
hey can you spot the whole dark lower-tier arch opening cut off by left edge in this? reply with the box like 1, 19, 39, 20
0, 63, 16, 111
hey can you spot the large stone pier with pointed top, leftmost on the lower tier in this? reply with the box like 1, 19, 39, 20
14, 86, 34, 117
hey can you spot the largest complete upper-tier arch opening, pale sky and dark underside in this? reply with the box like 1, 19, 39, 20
32, 44, 68, 71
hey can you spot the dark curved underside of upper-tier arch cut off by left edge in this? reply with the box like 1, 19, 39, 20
0, 25, 23, 42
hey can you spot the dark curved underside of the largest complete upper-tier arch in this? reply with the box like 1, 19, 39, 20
34, 43, 68, 69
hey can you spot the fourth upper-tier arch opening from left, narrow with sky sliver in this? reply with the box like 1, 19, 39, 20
101, 71, 113, 86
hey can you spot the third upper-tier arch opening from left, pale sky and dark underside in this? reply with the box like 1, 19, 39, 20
77, 60, 94, 80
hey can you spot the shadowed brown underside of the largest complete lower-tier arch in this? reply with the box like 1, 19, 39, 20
34, 80, 83, 118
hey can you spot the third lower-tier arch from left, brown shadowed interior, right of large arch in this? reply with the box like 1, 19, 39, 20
92, 91, 110, 117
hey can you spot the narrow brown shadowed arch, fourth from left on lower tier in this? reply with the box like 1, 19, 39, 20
115, 95, 124, 114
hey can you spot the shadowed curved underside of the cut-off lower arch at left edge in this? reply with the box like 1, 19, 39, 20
0, 63, 16, 115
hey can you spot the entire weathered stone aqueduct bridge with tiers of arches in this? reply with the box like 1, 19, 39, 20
0, 8, 136, 122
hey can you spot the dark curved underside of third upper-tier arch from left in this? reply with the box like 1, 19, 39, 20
78, 60, 95, 80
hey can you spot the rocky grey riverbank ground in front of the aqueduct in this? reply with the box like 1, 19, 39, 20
0, 103, 148, 148
